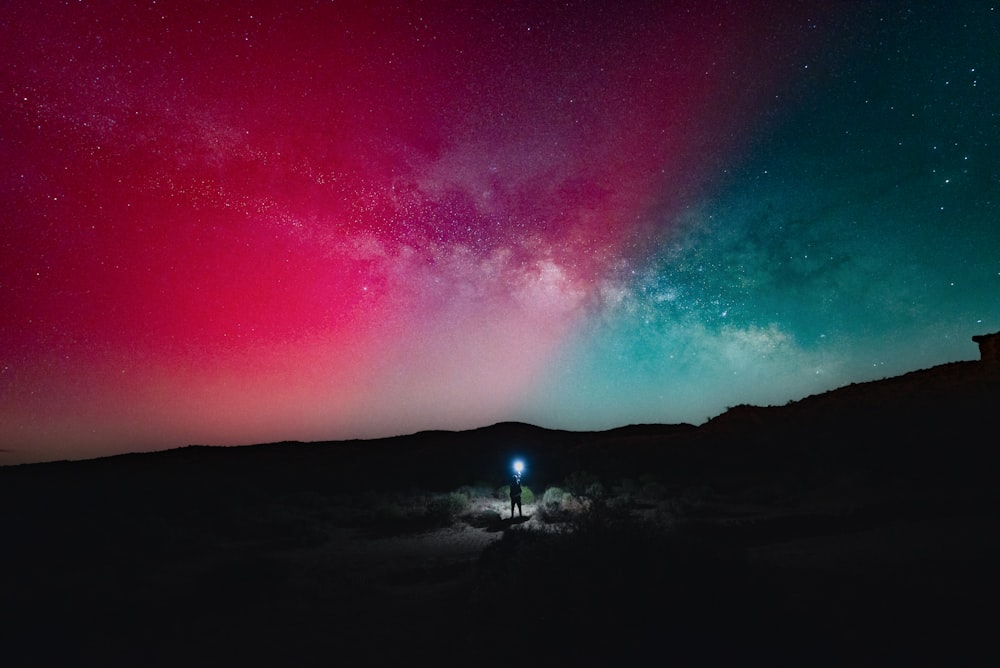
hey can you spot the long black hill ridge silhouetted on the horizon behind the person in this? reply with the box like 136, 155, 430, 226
0, 361, 1000, 493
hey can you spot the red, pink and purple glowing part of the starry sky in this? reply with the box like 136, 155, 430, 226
0, 2, 824, 461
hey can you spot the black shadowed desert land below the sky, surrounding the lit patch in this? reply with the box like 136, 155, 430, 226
0, 362, 1000, 666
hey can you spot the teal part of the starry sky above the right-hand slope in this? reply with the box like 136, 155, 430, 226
526, 3, 1000, 428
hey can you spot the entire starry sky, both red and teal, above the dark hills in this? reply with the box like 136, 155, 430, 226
0, 0, 1000, 464
